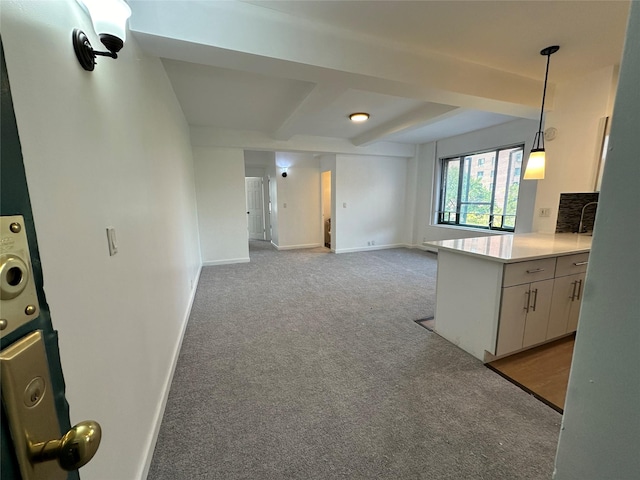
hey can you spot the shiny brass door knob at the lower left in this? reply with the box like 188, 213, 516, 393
29, 420, 102, 470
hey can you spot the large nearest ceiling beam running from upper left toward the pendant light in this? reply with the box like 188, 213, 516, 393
130, 1, 552, 109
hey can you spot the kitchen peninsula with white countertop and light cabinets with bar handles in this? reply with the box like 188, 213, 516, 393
424, 233, 591, 362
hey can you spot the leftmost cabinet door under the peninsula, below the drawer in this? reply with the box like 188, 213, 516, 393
496, 284, 530, 355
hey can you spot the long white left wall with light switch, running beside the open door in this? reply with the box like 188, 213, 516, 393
1, 0, 200, 480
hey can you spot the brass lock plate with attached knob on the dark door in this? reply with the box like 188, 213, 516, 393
0, 330, 102, 480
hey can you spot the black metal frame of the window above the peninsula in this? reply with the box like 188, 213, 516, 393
435, 142, 525, 233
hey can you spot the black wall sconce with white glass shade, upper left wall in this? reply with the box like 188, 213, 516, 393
72, 0, 131, 71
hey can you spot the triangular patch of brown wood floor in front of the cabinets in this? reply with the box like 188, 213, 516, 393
487, 335, 575, 413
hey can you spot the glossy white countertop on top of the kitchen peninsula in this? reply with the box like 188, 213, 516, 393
424, 233, 592, 263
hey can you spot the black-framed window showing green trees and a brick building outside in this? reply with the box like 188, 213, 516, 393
438, 145, 524, 232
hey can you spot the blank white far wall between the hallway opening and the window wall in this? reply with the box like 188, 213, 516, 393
332, 155, 408, 253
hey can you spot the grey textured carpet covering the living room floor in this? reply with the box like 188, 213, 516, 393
148, 242, 561, 480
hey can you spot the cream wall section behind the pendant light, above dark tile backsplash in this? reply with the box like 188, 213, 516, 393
533, 64, 617, 232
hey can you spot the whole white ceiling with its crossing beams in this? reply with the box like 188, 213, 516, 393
130, 0, 629, 150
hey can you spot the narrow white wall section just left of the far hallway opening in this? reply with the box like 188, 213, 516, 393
193, 147, 249, 265
